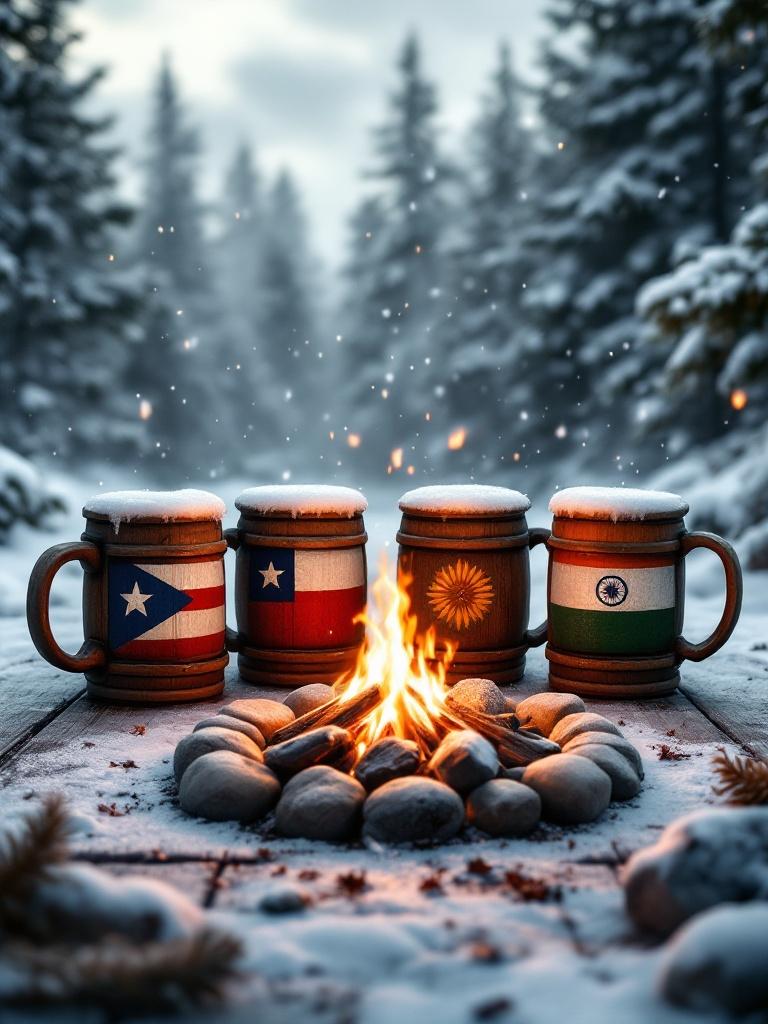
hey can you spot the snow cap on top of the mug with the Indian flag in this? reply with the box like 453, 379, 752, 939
549, 486, 688, 522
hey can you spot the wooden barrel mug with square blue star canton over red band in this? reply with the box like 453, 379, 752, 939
224, 484, 368, 687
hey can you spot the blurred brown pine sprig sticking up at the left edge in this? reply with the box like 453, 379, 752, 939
0, 794, 72, 901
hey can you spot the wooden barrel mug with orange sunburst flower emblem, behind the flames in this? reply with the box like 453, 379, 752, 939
397, 484, 549, 684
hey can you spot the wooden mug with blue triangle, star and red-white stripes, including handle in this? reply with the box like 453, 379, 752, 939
27, 490, 228, 703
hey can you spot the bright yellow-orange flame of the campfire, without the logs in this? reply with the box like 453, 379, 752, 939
341, 557, 456, 755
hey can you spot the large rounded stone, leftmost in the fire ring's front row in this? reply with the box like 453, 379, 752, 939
179, 749, 280, 822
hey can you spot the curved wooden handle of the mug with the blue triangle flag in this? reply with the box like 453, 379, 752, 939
27, 541, 106, 672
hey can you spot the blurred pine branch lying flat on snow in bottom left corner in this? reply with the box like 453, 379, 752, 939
5, 929, 243, 1016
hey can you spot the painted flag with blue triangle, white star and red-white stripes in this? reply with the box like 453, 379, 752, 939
109, 558, 225, 662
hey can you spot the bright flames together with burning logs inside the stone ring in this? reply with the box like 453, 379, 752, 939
271, 561, 559, 767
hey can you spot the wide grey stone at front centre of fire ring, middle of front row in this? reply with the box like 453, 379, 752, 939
362, 776, 464, 845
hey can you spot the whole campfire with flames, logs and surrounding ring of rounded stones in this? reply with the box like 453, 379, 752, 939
174, 564, 642, 844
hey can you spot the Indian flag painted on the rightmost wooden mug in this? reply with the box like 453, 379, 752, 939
549, 550, 676, 654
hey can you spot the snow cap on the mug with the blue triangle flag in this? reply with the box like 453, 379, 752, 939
83, 487, 226, 534
